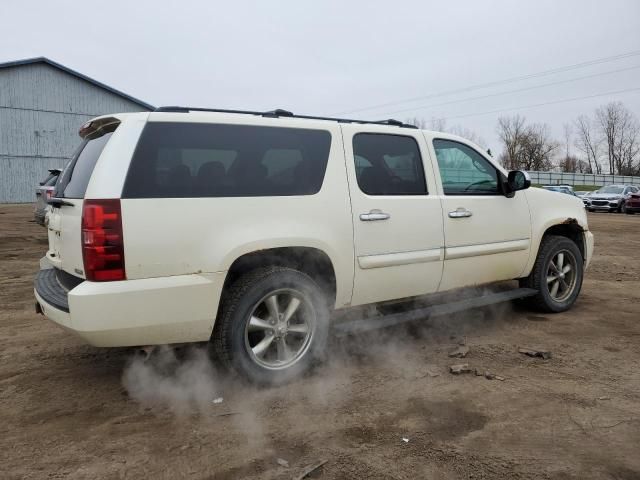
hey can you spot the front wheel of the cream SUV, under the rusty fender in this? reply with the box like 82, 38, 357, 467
520, 235, 584, 313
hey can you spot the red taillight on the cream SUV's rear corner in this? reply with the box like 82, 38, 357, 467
82, 199, 126, 282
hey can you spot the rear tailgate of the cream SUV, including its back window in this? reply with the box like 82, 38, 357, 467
47, 118, 119, 278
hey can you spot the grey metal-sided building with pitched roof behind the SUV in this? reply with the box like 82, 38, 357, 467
0, 57, 154, 203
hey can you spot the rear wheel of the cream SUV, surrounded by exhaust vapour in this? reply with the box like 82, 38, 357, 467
212, 267, 329, 385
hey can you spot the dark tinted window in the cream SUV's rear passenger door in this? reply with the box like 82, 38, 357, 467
353, 133, 427, 195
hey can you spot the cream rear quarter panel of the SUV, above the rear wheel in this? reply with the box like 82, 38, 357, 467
121, 115, 354, 307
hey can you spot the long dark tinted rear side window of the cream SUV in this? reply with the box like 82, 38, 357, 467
122, 122, 331, 198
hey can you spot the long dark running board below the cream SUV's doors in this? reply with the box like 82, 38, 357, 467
333, 288, 538, 337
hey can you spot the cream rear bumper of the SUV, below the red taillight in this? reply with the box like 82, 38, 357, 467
35, 264, 225, 347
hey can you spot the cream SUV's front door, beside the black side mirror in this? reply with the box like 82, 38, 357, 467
425, 134, 531, 290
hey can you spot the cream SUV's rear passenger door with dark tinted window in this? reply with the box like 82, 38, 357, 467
342, 125, 444, 305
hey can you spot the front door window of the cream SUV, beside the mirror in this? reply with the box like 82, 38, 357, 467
433, 139, 500, 195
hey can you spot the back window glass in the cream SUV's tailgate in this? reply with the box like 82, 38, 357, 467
55, 124, 117, 198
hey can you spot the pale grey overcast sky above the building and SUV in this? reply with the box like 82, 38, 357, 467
0, 0, 640, 151
